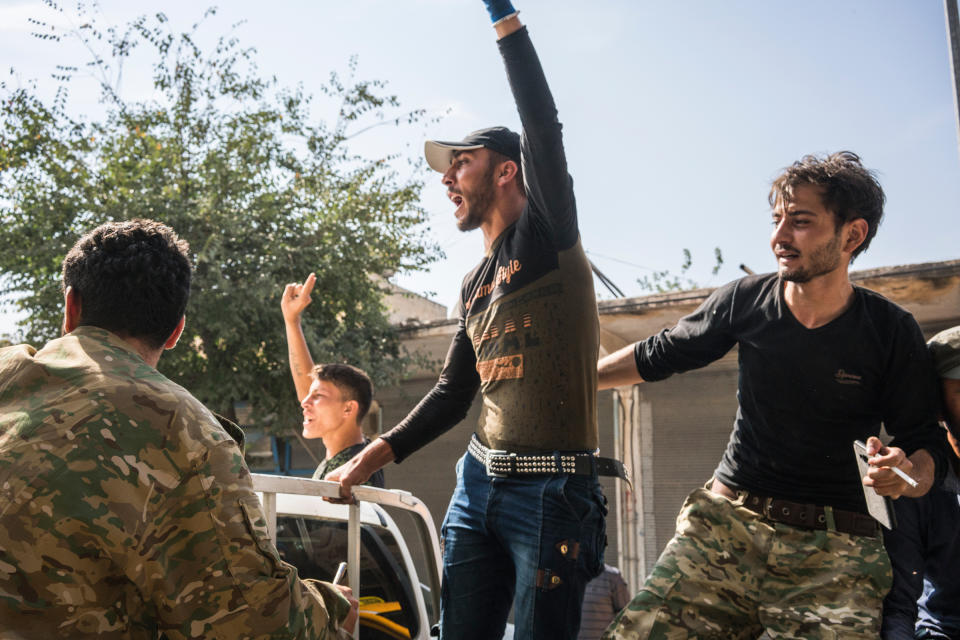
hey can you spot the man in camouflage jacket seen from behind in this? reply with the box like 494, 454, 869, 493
0, 220, 356, 639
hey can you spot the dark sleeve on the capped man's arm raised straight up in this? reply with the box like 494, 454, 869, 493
497, 27, 578, 249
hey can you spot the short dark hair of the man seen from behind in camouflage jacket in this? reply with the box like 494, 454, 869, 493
62, 219, 190, 349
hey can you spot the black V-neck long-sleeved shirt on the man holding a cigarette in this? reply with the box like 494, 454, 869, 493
635, 274, 947, 512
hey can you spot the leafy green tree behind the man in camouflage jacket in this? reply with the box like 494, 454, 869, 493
0, 0, 439, 430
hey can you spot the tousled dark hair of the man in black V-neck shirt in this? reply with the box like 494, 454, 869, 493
767, 151, 886, 258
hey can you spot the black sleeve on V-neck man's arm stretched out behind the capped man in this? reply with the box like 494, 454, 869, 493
633, 282, 736, 382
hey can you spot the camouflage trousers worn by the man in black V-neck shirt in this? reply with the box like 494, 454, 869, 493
603, 482, 892, 640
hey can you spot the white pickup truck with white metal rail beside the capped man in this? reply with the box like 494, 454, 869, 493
253, 474, 440, 640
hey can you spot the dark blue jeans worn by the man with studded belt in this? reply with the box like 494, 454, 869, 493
440, 454, 607, 640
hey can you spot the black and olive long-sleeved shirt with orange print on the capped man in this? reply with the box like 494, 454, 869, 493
383, 29, 600, 462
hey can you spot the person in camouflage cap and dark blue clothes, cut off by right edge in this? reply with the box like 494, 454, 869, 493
882, 326, 960, 640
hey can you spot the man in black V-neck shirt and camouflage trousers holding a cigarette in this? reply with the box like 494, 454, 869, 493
598, 152, 947, 639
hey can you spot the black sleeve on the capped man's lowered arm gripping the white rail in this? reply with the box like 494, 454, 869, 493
383, 315, 480, 462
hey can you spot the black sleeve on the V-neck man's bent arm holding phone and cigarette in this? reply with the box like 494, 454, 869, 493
881, 315, 952, 485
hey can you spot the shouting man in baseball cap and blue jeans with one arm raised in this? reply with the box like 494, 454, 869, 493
327, 0, 623, 640
